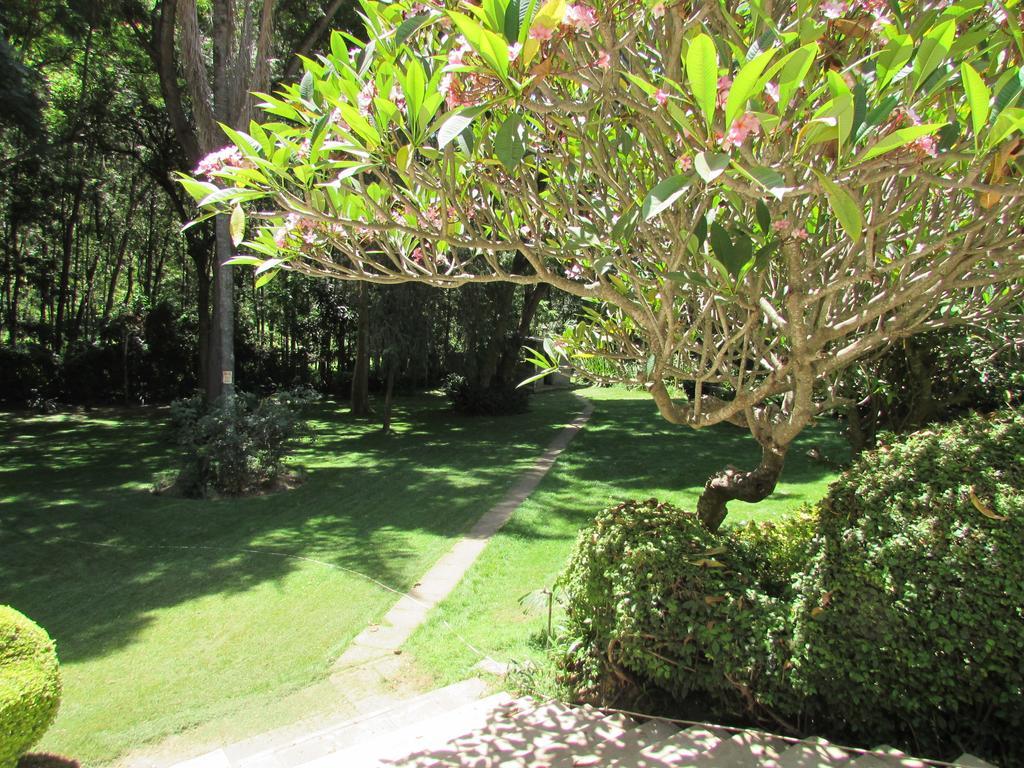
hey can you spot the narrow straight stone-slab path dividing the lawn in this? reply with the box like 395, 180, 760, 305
332, 397, 594, 679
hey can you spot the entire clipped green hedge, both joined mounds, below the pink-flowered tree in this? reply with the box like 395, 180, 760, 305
561, 411, 1024, 764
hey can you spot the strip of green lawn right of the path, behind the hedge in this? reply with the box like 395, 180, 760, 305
407, 389, 848, 684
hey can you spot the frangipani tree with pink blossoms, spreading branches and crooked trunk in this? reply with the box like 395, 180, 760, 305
182, 0, 1024, 529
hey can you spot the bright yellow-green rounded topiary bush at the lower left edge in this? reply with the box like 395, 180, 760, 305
0, 605, 60, 768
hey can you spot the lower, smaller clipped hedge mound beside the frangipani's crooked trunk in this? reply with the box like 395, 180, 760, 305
562, 500, 787, 717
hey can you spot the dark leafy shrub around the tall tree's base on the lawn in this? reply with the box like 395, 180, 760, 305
165, 389, 317, 498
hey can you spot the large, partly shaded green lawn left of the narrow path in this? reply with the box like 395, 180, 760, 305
0, 393, 577, 765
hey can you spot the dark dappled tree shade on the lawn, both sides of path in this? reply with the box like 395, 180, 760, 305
0, 387, 840, 662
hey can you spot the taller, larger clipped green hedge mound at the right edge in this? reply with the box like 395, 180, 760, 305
786, 412, 1024, 764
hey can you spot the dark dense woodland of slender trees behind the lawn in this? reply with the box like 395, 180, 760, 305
0, 0, 574, 407
